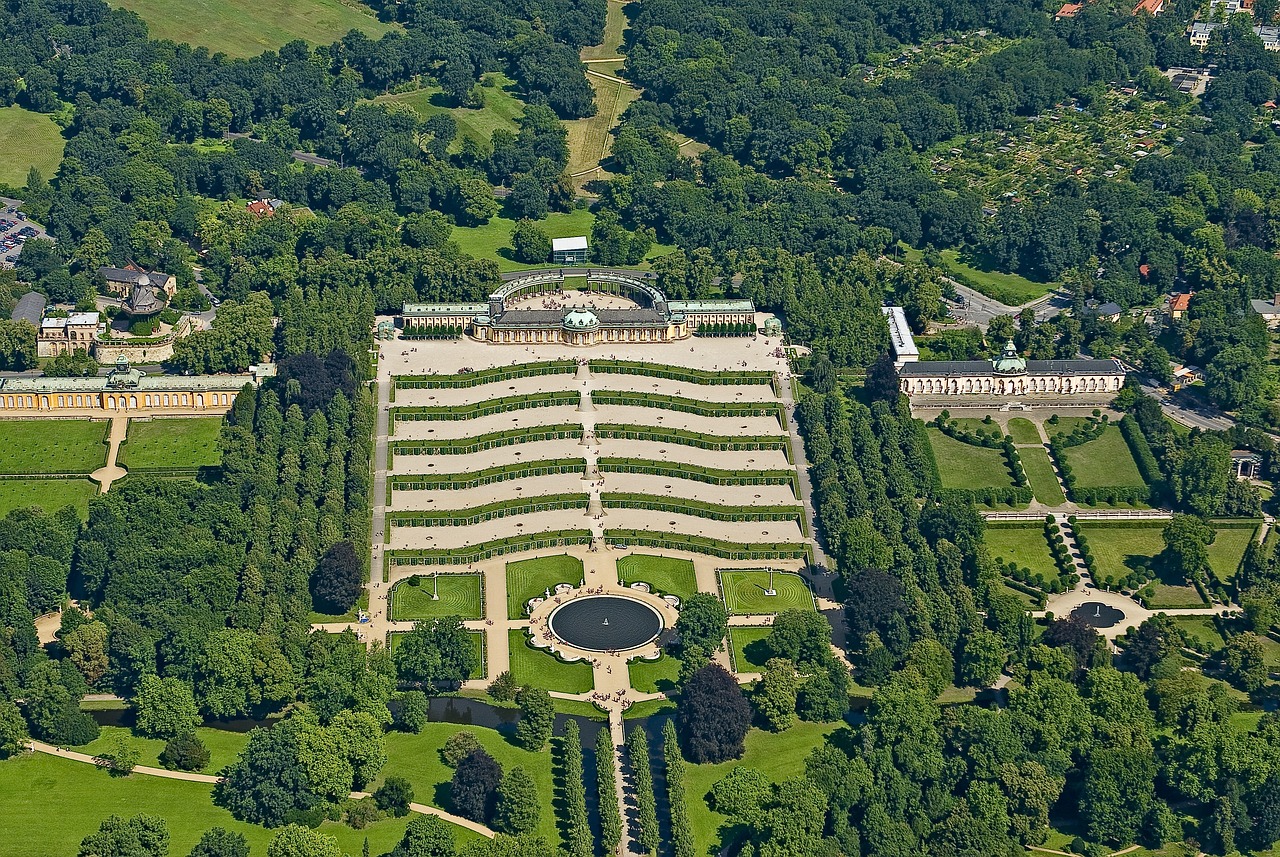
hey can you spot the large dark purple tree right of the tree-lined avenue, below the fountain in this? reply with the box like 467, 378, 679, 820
676, 664, 751, 764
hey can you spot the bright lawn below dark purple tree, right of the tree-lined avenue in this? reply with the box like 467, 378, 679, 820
680, 721, 840, 854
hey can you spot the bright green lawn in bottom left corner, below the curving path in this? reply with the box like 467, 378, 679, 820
0, 757, 476, 857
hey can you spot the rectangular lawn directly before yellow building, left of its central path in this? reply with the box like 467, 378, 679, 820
0, 420, 109, 473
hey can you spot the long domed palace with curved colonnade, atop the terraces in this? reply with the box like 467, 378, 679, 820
401, 271, 755, 345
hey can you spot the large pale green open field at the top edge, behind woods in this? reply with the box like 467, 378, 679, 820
111, 0, 393, 56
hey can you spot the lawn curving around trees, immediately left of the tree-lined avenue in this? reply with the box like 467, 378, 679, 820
378, 723, 561, 854
